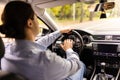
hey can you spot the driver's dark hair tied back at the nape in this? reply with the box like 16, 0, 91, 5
0, 1, 34, 39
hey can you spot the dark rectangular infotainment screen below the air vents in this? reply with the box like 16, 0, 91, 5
97, 44, 118, 53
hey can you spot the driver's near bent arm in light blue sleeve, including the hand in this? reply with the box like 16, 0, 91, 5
43, 39, 81, 80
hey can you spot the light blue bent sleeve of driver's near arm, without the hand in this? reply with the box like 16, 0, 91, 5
43, 51, 81, 80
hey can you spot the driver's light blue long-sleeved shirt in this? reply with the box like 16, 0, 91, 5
1, 31, 81, 80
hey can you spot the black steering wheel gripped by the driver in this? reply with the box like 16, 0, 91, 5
52, 30, 84, 58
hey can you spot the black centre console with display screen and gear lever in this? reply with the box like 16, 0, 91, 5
91, 42, 120, 80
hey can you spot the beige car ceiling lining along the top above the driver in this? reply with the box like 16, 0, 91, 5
0, 0, 96, 8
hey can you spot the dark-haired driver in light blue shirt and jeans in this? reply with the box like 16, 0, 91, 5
0, 1, 85, 80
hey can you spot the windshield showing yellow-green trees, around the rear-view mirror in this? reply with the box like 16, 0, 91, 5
46, 0, 120, 28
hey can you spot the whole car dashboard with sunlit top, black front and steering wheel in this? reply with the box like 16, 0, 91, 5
48, 19, 120, 80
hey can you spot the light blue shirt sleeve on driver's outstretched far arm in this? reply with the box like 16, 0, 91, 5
37, 31, 61, 48
